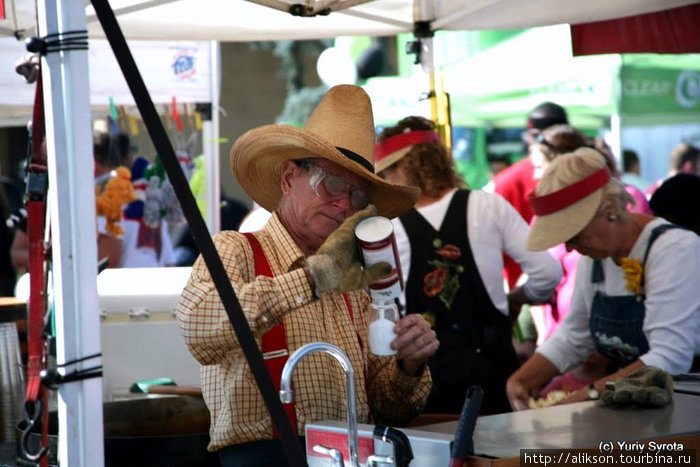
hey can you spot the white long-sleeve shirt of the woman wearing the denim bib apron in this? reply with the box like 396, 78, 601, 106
537, 219, 700, 374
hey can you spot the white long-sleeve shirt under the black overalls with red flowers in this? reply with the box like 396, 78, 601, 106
392, 190, 562, 316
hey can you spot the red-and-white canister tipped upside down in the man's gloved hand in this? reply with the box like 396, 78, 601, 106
355, 216, 403, 303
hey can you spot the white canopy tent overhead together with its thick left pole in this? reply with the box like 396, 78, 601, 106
0, 0, 697, 467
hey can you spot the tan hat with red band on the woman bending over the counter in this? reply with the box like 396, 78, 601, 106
526, 148, 611, 251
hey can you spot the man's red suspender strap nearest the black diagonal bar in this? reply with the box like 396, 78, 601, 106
243, 232, 298, 438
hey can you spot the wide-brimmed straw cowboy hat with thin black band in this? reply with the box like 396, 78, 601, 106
230, 84, 420, 218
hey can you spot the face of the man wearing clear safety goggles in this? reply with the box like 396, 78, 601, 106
279, 159, 369, 252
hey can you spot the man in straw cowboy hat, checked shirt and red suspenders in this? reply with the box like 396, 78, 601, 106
177, 85, 438, 466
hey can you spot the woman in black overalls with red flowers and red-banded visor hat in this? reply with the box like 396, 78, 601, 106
375, 117, 561, 414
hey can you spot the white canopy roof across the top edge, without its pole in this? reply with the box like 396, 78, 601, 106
0, 0, 697, 41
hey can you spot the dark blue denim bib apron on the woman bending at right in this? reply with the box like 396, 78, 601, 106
589, 224, 679, 369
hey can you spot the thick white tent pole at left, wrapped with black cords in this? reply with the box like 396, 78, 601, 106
37, 0, 104, 467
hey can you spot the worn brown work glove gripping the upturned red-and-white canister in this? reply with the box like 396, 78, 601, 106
306, 204, 391, 296
